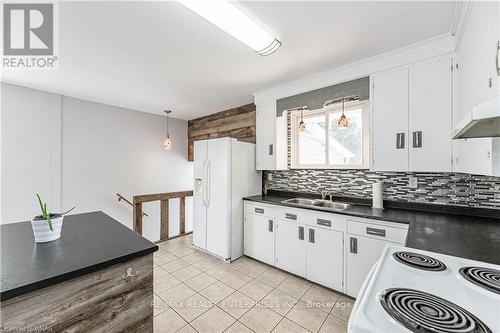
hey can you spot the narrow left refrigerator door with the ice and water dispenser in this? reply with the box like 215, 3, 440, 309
193, 140, 208, 250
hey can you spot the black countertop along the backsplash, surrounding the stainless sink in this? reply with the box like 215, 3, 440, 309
244, 194, 500, 265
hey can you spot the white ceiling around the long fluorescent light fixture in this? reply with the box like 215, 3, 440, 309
2, 1, 454, 120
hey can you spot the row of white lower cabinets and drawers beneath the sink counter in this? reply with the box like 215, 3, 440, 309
244, 203, 408, 297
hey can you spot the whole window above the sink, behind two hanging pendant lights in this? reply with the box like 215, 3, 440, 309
291, 101, 368, 169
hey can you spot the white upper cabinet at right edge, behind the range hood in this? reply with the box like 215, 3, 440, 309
453, 1, 500, 175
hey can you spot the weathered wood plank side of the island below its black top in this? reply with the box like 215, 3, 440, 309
0, 254, 153, 333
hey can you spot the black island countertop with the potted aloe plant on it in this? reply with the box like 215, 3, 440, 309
0, 212, 158, 301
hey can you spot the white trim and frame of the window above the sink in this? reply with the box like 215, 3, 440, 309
290, 100, 370, 170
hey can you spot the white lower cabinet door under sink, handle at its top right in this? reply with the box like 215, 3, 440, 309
276, 220, 306, 277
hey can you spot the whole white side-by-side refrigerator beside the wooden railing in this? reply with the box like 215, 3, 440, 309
193, 138, 262, 260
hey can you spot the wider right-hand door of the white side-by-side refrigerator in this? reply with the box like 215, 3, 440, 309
206, 138, 231, 259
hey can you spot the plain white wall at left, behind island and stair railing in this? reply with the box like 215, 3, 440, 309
1, 83, 192, 240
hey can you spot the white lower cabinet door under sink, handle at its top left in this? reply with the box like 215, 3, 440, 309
307, 228, 344, 291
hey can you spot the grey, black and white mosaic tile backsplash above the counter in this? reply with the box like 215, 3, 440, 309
266, 169, 500, 210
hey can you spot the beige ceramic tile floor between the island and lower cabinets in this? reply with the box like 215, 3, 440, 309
154, 235, 354, 333
